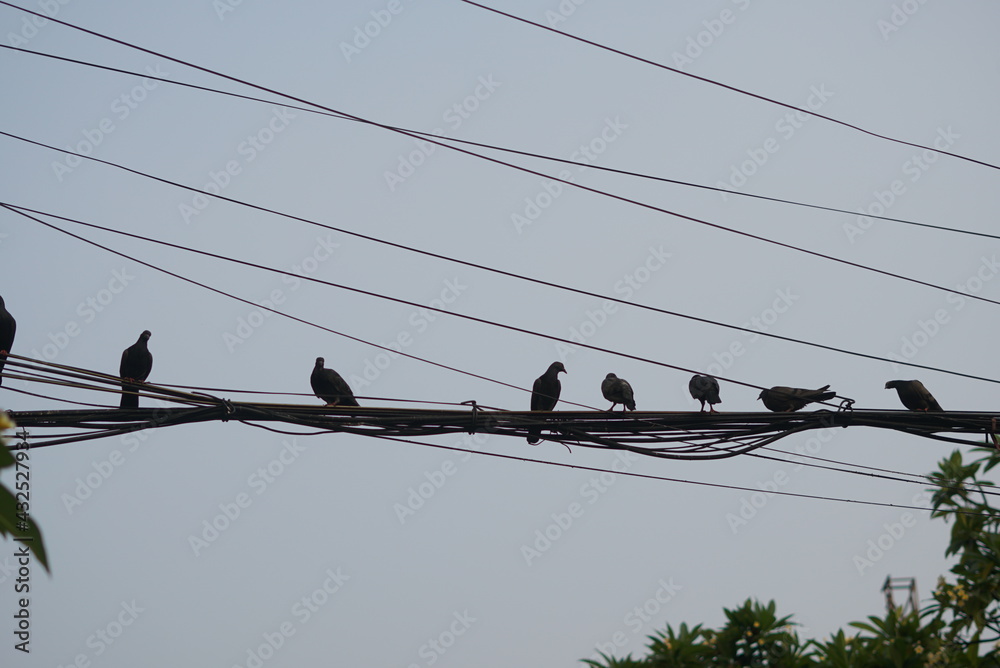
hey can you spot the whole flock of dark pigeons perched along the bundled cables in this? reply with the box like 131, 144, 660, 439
0, 297, 943, 444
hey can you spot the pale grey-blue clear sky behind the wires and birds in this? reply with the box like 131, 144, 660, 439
0, 0, 1000, 668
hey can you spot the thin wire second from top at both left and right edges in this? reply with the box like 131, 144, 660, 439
0, 44, 1000, 239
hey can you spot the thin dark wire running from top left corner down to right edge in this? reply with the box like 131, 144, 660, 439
0, 7, 1000, 305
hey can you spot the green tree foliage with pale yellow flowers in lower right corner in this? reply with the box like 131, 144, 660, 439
584, 448, 1000, 668
